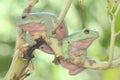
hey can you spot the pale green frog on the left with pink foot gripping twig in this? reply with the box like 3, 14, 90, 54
17, 12, 67, 43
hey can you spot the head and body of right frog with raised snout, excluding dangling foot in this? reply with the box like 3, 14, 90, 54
62, 29, 98, 64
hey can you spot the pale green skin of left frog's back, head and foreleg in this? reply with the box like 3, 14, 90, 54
18, 12, 57, 36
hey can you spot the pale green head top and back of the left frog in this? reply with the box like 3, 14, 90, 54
18, 12, 57, 24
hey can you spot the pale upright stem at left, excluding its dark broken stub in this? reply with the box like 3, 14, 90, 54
4, 28, 30, 80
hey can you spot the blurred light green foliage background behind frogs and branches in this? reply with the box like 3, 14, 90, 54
0, 0, 120, 80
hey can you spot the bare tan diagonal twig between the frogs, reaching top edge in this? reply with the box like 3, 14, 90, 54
53, 0, 73, 33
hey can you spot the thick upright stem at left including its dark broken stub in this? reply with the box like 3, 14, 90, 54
5, 28, 45, 80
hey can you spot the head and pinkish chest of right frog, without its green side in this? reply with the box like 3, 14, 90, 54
68, 29, 98, 65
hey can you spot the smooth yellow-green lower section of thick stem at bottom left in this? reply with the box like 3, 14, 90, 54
4, 52, 29, 80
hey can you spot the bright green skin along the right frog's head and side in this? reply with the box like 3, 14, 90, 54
62, 30, 98, 60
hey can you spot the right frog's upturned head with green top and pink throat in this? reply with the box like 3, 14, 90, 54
67, 29, 98, 53
